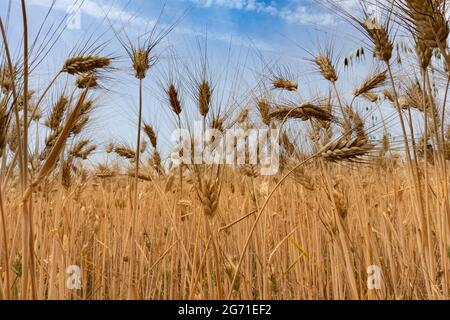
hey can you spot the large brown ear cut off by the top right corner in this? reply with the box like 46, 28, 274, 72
405, 0, 449, 48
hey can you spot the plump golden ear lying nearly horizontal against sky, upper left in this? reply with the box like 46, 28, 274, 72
62, 55, 111, 75
